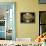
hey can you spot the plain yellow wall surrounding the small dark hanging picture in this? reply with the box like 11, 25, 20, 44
0, 0, 46, 38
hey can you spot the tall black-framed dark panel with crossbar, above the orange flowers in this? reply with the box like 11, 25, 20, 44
39, 11, 46, 35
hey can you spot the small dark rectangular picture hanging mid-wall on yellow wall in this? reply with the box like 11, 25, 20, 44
20, 12, 35, 23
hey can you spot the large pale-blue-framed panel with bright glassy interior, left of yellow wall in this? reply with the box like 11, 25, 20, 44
0, 2, 16, 40
